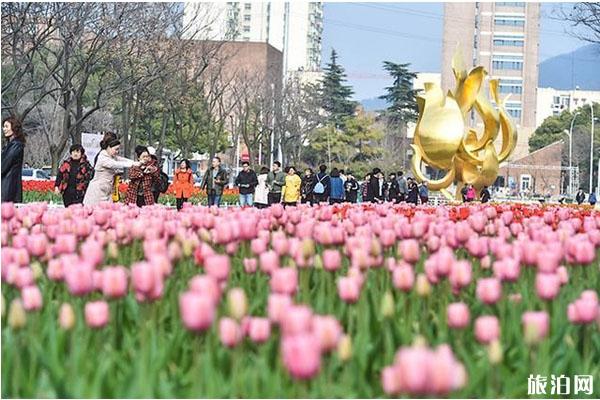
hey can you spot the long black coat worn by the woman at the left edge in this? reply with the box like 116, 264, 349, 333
2, 139, 25, 203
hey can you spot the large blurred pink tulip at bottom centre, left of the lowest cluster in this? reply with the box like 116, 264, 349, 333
281, 333, 321, 379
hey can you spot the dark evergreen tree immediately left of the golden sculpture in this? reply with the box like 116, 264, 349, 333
379, 61, 418, 126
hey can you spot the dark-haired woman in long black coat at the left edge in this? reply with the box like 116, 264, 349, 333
2, 117, 25, 203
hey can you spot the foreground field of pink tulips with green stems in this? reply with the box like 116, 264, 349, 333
1, 203, 600, 398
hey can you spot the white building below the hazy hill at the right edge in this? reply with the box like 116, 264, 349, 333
535, 88, 600, 126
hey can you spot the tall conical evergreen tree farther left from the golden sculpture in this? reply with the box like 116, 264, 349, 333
321, 50, 357, 129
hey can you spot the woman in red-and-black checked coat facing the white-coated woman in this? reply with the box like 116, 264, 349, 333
125, 146, 160, 207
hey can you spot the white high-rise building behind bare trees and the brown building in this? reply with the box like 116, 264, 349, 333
184, 1, 323, 73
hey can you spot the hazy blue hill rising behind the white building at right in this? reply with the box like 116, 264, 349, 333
538, 44, 600, 90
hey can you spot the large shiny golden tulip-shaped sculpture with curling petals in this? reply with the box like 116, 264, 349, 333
411, 51, 517, 199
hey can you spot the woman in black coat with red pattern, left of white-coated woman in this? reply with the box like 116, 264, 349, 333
54, 144, 94, 207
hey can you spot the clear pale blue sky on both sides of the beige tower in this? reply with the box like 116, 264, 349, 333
322, 2, 588, 100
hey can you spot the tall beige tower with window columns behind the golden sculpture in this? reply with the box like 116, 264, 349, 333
442, 2, 540, 157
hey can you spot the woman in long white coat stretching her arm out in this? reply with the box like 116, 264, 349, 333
83, 139, 139, 206
